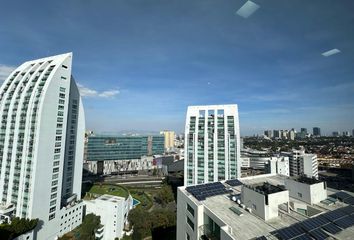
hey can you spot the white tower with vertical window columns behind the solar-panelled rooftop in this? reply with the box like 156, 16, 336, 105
184, 104, 241, 185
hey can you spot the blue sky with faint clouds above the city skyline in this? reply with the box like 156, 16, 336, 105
0, 0, 354, 135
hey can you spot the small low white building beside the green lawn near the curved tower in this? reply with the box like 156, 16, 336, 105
84, 194, 133, 240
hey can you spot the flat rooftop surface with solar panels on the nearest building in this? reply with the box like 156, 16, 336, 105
181, 174, 354, 240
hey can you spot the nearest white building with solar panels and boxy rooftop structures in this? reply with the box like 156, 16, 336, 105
177, 174, 354, 240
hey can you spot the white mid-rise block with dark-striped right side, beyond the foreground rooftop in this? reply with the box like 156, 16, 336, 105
281, 149, 318, 178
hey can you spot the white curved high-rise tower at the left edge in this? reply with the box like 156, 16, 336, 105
0, 53, 85, 239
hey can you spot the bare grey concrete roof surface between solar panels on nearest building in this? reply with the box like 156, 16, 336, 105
181, 174, 354, 240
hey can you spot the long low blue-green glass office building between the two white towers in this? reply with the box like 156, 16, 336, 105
85, 135, 165, 174
